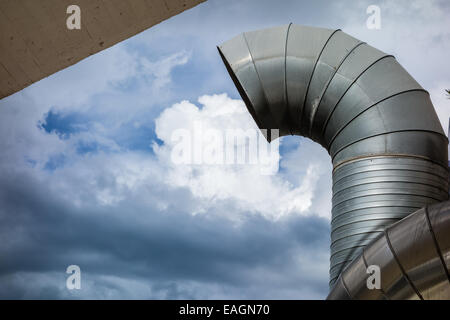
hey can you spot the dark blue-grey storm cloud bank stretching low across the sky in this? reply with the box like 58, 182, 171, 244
0, 165, 329, 298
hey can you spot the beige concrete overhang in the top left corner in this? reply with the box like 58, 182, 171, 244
0, 0, 205, 98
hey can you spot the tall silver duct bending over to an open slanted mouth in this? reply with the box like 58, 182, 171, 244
218, 24, 448, 286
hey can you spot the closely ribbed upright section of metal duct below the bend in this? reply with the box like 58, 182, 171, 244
330, 157, 448, 283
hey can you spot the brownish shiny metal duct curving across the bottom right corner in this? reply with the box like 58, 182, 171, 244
328, 201, 450, 300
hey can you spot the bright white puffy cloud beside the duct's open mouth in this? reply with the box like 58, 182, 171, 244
155, 94, 329, 220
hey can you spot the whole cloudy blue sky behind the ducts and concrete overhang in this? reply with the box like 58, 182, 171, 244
0, 0, 450, 299
